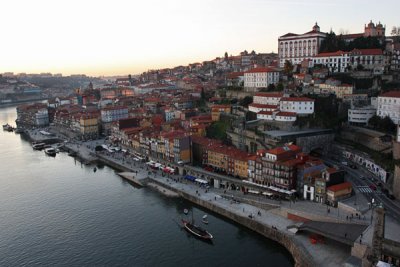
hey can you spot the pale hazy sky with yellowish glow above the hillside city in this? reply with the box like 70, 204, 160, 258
0, 0, 400, 75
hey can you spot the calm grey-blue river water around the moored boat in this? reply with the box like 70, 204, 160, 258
0, 107, 294, 267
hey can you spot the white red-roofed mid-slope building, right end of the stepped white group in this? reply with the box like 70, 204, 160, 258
279, 97, 314, 115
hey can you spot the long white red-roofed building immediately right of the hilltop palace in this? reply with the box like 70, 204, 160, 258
312, 50, 350, 72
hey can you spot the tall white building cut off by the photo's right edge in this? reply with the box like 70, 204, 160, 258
376, 91, 400, 124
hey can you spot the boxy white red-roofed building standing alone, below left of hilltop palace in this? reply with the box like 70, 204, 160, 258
244, 67, 279, 91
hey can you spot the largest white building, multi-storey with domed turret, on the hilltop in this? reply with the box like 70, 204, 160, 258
278, 23, 327, 67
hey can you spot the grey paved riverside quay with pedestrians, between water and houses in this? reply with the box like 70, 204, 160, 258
24, 129, 350, 267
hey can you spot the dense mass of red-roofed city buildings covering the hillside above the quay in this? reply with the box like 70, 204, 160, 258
11, 18, 400, 205
